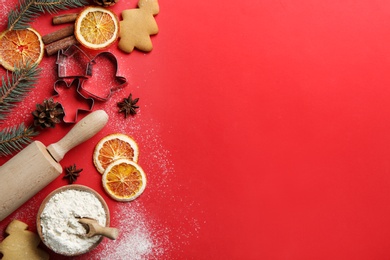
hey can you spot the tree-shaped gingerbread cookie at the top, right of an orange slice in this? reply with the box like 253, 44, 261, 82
118, 0, 160, 53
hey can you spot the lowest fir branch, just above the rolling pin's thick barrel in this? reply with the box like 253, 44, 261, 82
0, 123, 38, 156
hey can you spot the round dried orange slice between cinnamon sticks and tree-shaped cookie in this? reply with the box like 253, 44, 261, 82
74, 6, 119, 50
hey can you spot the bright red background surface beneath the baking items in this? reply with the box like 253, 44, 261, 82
0, 0, 390, 260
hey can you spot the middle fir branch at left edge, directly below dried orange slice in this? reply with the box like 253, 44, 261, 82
0, 64, 40, 120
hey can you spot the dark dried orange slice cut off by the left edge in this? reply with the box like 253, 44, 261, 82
0, 28, 44, 71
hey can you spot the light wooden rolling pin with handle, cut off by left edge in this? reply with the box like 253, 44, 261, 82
0, 110, 108, 221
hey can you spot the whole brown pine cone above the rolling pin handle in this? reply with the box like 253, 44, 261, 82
32, 98, 64, 128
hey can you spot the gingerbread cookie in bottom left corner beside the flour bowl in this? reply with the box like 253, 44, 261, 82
0, 220, 49, 260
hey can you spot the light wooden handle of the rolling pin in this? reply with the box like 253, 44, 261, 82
47, 110, 108, 162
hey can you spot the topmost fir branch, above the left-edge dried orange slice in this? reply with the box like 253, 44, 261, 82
7, 0, 88, 30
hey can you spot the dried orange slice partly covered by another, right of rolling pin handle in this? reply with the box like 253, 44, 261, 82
93, 133, 139, 174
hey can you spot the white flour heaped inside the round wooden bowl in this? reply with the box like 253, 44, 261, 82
41, 189, 106, 255
